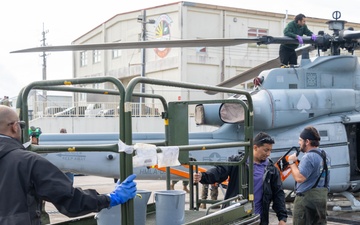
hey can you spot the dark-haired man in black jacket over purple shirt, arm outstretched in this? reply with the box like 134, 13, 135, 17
194, 132, 287, 225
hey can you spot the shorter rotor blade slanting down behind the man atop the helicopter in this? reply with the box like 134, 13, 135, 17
205, 45, 315, 95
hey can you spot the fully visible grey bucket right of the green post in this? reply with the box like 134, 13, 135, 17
154, 190, 185, 225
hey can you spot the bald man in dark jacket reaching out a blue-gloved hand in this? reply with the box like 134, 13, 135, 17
0, 105, 136, 225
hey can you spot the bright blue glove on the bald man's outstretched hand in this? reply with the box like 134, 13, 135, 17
109, 174, 136, 207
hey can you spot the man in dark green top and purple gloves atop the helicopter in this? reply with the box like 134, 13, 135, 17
279, 14, 316, 66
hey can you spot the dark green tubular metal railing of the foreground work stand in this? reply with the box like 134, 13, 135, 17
17, 77, 258, 224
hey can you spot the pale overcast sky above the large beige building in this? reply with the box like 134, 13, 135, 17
0, 0, 360, 98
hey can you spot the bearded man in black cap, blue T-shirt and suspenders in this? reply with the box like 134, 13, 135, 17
288, 126, 330, 225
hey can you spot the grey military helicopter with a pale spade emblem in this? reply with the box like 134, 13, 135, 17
13, 11, 360, 211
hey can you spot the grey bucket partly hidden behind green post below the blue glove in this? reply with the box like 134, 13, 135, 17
95, 190, 151, 225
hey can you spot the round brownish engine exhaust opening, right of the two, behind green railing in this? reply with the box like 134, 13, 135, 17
219, 103, 244, 123
